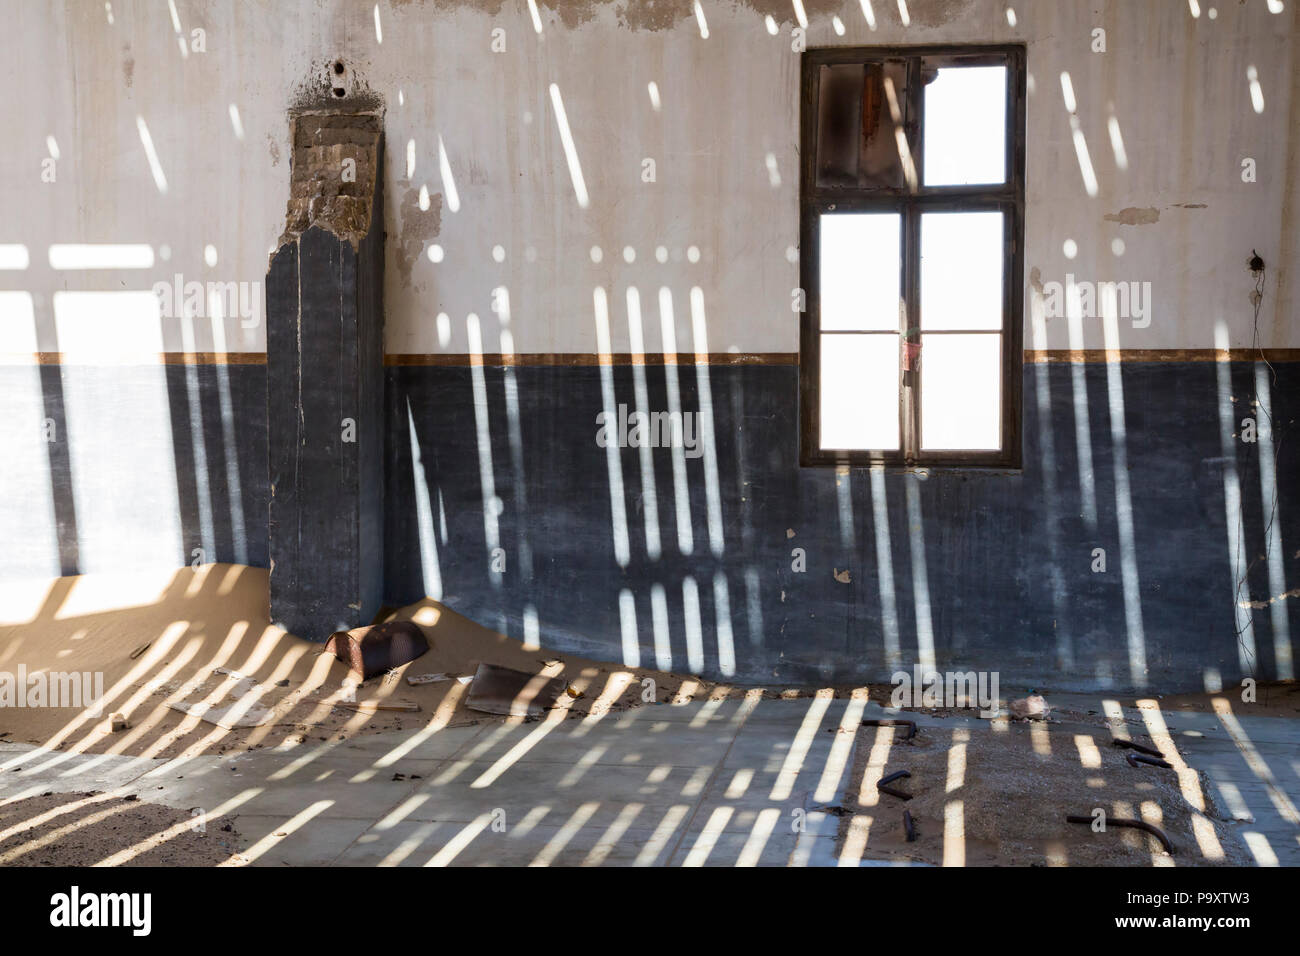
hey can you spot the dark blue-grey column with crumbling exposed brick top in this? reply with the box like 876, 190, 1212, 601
267, 112, 384, 641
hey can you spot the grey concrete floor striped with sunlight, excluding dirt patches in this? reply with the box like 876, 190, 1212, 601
0, 696, 1300, 866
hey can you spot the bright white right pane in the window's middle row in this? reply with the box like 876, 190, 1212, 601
920, 212, 1002, 330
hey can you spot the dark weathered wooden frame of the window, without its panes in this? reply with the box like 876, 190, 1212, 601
800, 44, 1026, 470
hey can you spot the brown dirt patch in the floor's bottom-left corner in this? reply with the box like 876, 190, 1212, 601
0, 793, 239, 866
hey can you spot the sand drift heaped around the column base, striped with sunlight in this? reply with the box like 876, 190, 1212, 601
0, 564, 754, 757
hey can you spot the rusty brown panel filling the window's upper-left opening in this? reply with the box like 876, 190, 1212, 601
816, 61, 915, 189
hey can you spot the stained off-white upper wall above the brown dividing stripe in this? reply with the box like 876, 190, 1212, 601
0, 0, 1300, 354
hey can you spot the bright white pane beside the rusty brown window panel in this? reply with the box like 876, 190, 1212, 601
923, 66, 1006, 186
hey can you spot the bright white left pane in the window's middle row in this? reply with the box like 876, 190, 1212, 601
818, 212, 900, 330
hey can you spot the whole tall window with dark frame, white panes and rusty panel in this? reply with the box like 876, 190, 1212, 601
800, 47, 1024, 468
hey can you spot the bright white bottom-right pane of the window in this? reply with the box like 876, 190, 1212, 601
920, 333, 1002, 451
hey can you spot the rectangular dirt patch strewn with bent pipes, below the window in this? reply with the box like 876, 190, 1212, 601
832, 719, 1252, 866
